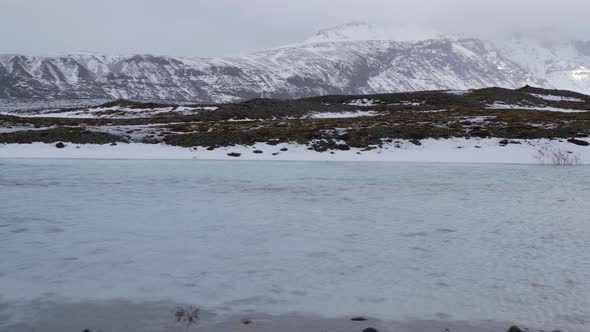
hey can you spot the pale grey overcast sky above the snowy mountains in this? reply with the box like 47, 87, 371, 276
0, 0, 590, 56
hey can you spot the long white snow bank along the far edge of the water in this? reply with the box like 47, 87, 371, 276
0, 138, 590, 164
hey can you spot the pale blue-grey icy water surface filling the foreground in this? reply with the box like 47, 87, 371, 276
0, 160, 590, 331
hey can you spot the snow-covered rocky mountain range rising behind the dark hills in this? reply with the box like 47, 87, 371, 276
0, 23, 590, 102
